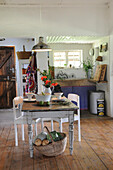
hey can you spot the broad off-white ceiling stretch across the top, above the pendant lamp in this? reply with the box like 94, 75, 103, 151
0, 0, 113, 40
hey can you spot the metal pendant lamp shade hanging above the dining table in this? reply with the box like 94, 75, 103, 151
32, 37, 52, 52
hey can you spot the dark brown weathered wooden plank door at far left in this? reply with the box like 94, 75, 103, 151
0, 46, 16, 109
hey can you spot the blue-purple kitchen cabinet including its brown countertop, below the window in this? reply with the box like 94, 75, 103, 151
56, 79, 96, 109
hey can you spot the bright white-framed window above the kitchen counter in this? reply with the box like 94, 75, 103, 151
53, 50, 83, 68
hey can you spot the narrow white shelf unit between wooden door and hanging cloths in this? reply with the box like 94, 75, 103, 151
19, 59, 29, 96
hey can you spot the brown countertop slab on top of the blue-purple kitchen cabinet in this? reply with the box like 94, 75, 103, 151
54, 79, 95, 86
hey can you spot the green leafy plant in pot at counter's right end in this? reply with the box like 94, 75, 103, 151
83, 58, 93, 79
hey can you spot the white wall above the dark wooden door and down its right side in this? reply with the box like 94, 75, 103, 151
0, 38, 34, 95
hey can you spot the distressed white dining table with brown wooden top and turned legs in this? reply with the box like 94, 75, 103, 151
22, 99, 78, 158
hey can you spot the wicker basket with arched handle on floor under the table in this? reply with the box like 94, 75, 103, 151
33, 126, 67, 156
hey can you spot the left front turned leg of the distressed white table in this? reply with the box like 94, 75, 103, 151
28, 118, 33, 158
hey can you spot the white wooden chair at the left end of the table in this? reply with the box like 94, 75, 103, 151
13, 96, 40, 146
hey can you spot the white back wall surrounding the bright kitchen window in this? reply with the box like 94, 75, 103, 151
49, 43, 92, 78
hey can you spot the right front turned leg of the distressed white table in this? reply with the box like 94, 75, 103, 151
69, 114, 74, 155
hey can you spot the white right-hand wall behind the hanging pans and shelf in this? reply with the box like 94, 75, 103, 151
93, 37, 111, 116
